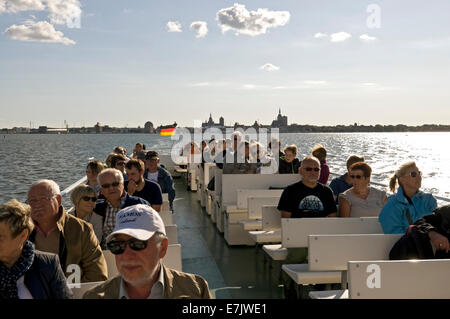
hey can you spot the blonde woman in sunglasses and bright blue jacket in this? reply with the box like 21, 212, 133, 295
378, 162, 437, 234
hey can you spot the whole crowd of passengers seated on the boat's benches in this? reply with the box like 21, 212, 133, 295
0, 132, 450, 299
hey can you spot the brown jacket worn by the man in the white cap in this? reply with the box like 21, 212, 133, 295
83, 265, 212, 299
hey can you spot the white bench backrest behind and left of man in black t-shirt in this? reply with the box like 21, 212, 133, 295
221, 174, 300, 205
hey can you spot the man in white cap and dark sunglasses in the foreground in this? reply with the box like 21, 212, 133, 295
83, 205, 211, 299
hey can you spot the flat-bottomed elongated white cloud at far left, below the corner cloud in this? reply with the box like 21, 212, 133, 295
5, 21, 75, 45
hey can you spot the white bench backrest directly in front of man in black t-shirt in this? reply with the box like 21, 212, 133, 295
281, 217, 383, 248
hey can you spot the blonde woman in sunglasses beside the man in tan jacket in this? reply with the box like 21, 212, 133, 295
70, 184, 103, 242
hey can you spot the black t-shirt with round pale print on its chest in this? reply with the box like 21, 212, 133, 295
277, 181, 337, 218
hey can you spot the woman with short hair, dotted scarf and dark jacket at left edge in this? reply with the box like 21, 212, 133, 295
0, 199, 72, 299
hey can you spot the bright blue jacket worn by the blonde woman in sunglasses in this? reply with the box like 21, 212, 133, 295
378, 187, 437, 234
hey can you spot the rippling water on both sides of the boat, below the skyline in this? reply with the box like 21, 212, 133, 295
0, 133, 450, 203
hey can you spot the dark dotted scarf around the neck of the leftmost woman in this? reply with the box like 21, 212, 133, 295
0, 240, 34, 299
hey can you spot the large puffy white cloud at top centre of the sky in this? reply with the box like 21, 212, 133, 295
216, 3, 291, 36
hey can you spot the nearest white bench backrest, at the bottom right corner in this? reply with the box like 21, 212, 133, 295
348, 259, 450, 299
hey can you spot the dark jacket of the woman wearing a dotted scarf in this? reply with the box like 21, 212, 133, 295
24, 250, 73, 299
